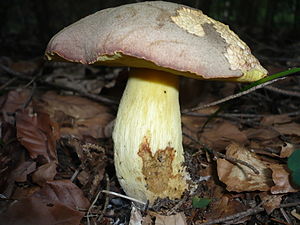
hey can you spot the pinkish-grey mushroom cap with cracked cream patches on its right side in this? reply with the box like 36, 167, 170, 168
45, 1, 267, 82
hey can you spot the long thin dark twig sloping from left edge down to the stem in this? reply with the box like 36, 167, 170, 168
0, 65, 118, 105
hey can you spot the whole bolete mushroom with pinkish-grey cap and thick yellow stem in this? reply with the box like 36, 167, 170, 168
46, 1, 267, 204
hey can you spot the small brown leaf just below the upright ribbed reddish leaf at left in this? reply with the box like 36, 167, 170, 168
32, 161, 56, 186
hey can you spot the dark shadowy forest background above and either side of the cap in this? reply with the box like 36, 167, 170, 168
0, 0, 300, 67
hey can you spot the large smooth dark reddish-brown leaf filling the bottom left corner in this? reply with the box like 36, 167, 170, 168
0, 180, 89, 225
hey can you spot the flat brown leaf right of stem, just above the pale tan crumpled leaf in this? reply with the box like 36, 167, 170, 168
201, 121, 248, 150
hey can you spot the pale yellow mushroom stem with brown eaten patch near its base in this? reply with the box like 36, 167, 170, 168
113, 69, 187, 204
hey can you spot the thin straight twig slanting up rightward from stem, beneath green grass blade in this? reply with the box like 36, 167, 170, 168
182, 77, 285, 113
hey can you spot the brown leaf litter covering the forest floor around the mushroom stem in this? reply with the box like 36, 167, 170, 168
0, 59, 300, 225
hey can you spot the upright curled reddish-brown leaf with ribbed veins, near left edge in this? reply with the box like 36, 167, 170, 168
16, 110, 59, 162
